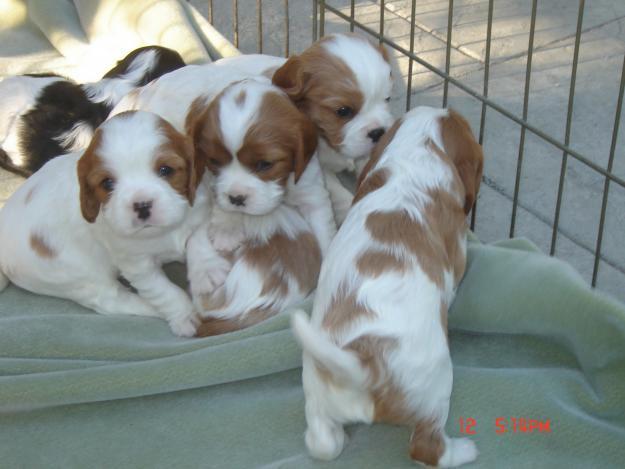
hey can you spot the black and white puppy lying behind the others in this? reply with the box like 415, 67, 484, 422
0, 46, 184, 176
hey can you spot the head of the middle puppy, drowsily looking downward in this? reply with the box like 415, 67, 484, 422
187, 80, 317, 215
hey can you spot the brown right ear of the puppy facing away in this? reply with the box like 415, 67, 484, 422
441, 109, 484, 214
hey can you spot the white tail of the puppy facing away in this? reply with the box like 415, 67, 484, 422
291, 310, 369, 387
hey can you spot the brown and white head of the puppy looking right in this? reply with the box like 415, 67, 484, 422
273, 34, 393, 159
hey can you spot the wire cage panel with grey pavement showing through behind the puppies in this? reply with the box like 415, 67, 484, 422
193, 0, 625, 300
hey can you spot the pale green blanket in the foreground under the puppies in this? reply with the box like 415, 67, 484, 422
0, 240, 625, 469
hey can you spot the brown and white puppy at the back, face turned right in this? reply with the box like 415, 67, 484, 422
216, 34, 393, 225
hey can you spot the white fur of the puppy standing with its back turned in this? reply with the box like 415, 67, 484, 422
293, 107, 477, 466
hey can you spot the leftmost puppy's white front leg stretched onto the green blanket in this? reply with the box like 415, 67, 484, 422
118, 258, 195, 337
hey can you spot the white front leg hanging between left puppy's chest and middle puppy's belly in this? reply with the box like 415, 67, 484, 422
187, 223, 232, 310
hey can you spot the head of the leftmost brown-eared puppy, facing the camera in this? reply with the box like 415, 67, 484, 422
77, 111, 198, 237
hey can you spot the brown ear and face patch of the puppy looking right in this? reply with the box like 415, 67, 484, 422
272, 37, 364, 154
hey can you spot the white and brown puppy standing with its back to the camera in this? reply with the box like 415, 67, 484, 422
293, 107, 483, 467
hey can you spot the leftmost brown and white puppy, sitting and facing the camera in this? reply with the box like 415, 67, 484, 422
0, 112, 209, 336
